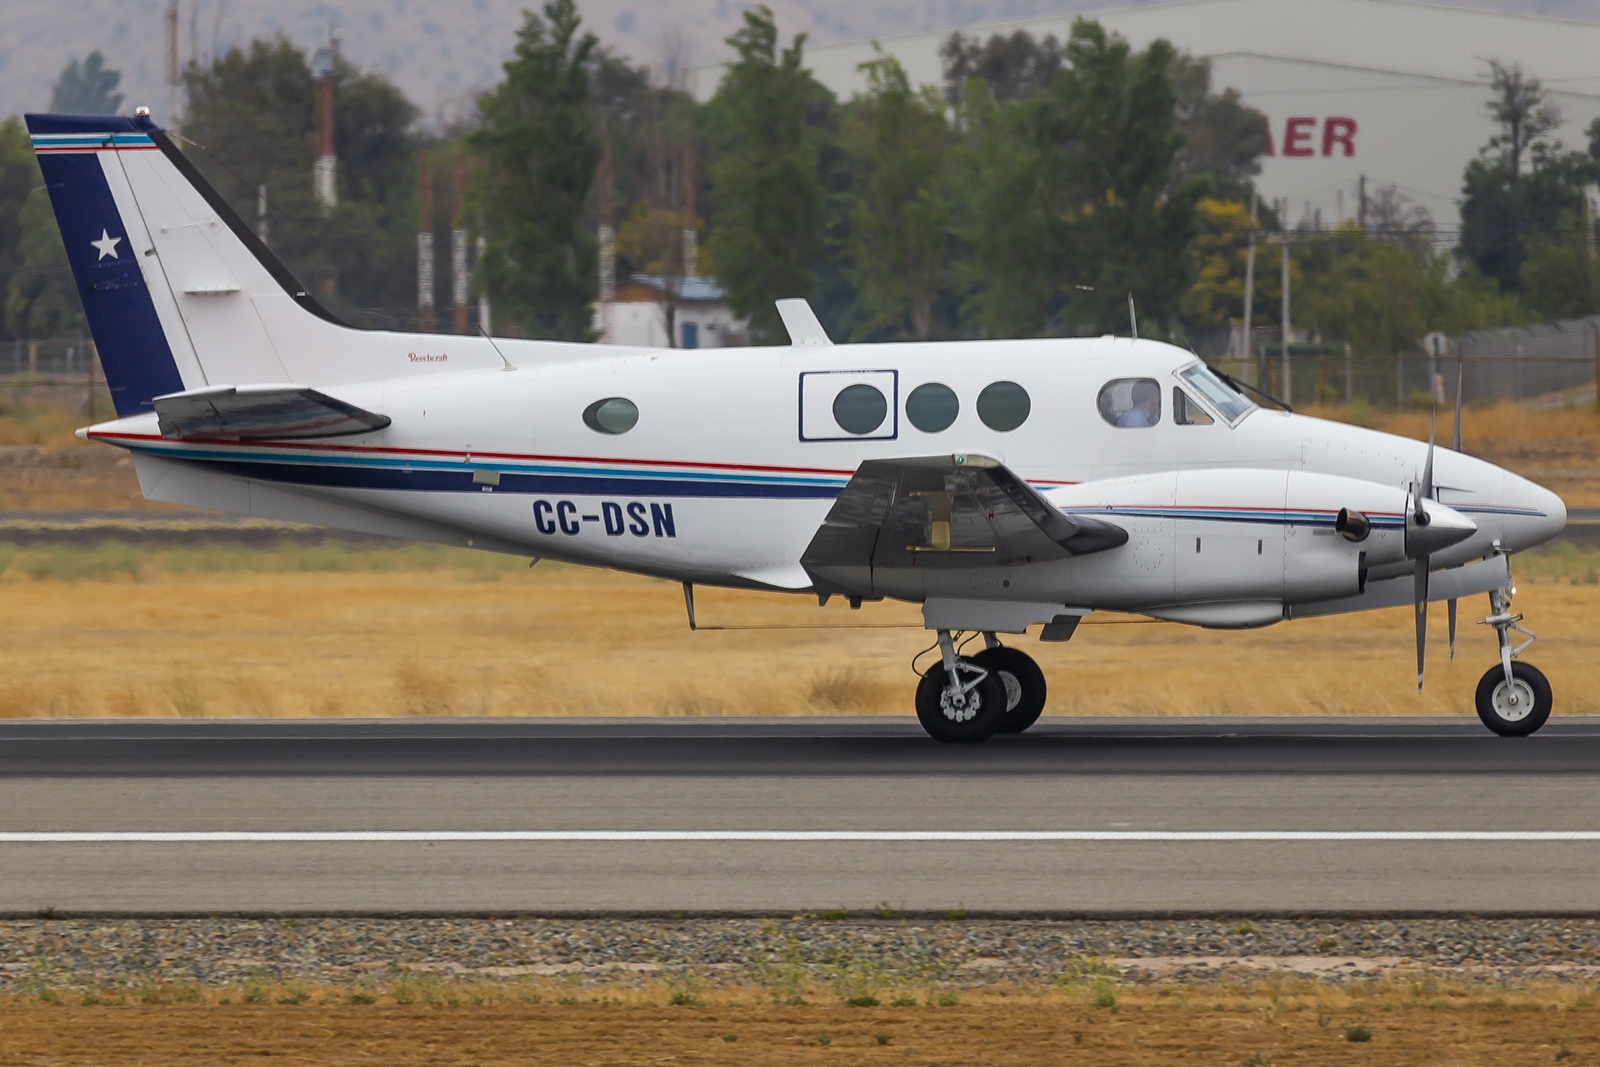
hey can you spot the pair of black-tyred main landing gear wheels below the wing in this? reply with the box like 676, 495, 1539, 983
917, 630, 1045, 741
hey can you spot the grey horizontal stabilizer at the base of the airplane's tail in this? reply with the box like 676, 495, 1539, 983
155, 384, 390, 442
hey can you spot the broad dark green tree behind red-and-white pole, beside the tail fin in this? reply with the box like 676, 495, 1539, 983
184, 37, 422, 326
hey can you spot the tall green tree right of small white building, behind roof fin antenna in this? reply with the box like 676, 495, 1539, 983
707, 5, 826, 344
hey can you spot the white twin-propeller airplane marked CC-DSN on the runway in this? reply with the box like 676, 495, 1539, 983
27, 109, 1566, 741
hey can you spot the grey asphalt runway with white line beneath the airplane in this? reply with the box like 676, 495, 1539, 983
0, 718, 1600, 915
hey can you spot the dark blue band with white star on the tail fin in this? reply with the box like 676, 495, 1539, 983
27, 115, 184, 416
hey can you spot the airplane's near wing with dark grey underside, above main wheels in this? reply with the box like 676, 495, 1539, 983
800, 453, 1128, 595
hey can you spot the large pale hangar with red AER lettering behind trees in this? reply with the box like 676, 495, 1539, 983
690, 0, 1600, 237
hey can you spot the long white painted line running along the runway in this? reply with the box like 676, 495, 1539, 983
0, 830, 1600, 845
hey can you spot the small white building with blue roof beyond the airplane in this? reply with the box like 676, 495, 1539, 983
595, 274, 750, 349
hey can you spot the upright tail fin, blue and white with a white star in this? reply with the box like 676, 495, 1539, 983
27, 115, 438, 416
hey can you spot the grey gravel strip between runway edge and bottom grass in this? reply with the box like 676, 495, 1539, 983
9, 918, 1600, 992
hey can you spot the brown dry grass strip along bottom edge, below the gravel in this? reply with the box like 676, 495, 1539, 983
0, 981, 1600, 1067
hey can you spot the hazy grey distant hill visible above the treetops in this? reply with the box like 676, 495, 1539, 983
0, 0, 1600, 120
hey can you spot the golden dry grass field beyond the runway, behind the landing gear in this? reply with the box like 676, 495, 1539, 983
0, 542, 1600, 717
